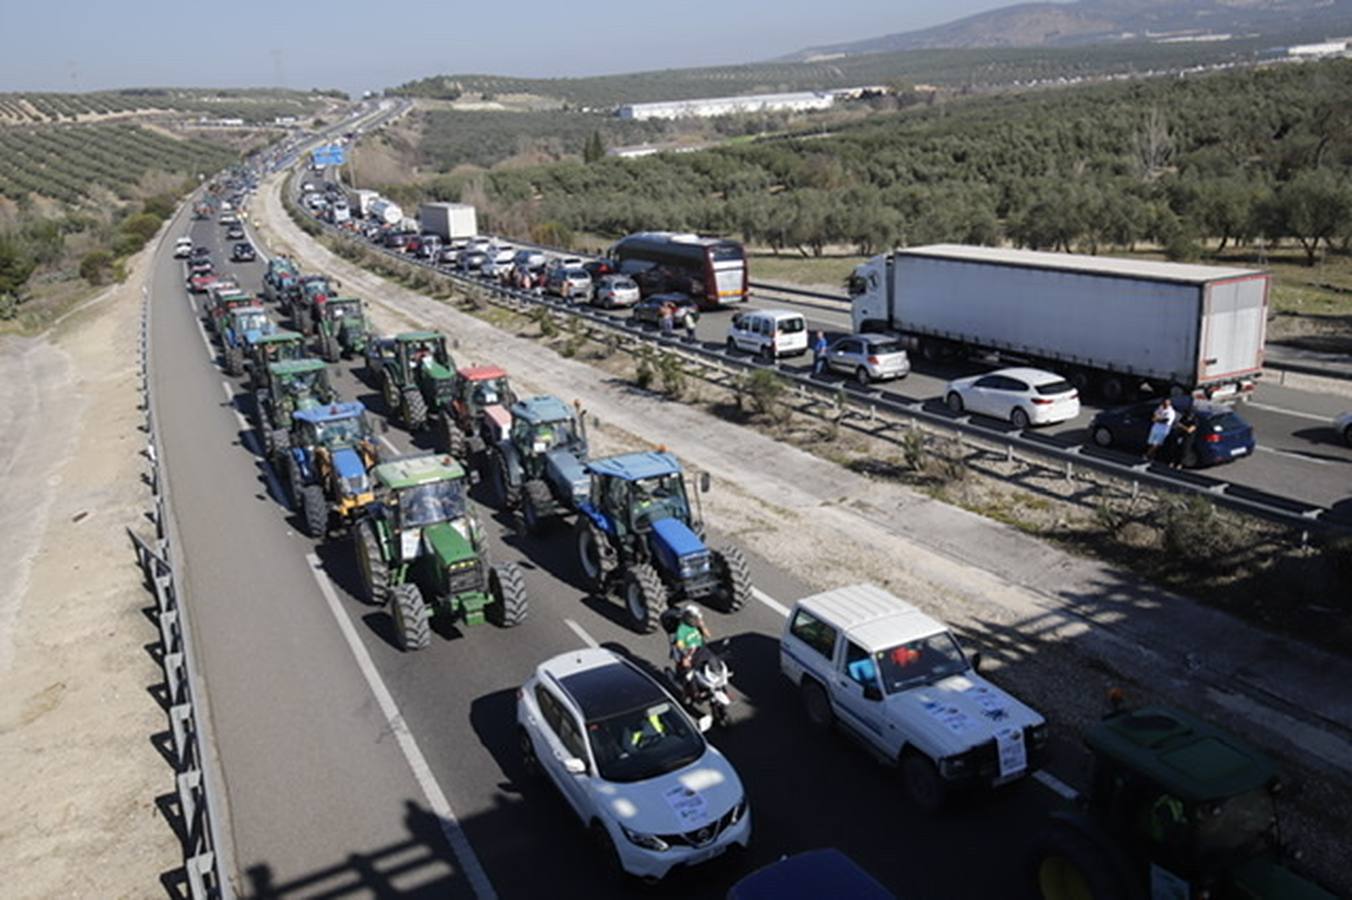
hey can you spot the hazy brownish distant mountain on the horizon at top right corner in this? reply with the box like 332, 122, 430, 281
783, 0, 1352, 61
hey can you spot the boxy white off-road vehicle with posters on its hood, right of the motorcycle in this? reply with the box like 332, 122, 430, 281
779, 585, 1046, 811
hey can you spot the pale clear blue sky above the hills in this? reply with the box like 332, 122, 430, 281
0, 0, 1014, 93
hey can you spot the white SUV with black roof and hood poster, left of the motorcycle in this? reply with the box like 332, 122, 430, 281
516, 649, 752, 878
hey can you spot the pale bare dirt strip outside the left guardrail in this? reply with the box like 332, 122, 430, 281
0, 235, 183, 897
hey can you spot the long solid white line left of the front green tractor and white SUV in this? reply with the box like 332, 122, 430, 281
306, 553, 498, 900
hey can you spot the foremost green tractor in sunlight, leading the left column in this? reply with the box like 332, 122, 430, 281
352, 454, 527, 650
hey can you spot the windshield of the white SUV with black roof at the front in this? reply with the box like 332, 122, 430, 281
587, 703, 704, 784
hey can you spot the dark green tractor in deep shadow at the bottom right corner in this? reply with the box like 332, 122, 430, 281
1029, 707, 1333, 900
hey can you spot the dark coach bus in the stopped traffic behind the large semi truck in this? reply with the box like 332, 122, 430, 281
610, 231, 746, 309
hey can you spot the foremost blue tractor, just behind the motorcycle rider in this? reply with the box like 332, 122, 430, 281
576, 451, 752, 634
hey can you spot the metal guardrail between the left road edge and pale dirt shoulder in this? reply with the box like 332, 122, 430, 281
127, 288, 235, 900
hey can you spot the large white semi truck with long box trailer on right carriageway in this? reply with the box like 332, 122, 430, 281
849, 245, 1270, 403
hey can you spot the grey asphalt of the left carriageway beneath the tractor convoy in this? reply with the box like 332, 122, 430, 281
151, 205, 1078, 897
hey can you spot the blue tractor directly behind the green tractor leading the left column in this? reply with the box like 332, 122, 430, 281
284, 401, 379, 538
